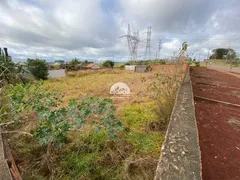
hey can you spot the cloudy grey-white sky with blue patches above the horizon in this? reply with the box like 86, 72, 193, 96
0, 0, 240, 61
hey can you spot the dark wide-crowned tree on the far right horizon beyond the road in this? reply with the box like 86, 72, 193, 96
210, 48, 236, 59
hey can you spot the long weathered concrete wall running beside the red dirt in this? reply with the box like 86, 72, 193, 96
155, 70, 202, 180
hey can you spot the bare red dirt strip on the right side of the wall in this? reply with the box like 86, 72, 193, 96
191, 67, 240, 180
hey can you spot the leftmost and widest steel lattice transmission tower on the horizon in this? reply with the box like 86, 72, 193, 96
120, 24, 140, 61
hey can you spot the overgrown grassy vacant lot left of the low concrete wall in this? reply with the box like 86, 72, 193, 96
7, 65, 183, 179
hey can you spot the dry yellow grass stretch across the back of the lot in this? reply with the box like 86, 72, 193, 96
45, 69, 161, 106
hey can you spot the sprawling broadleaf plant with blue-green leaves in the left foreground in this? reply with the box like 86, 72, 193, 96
9, 81, 123, 147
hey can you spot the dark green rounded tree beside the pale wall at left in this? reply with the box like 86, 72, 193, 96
27, 59, 48, 80
